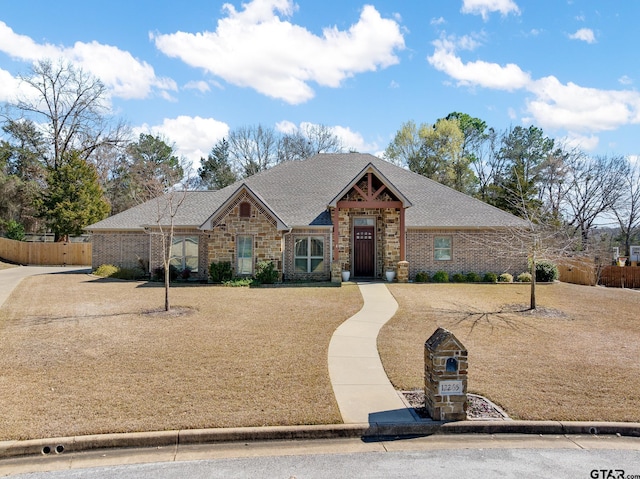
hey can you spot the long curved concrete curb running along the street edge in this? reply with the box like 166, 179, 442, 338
0, 420, 640, 460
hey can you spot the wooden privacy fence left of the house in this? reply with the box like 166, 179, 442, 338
0, 238, 91, 266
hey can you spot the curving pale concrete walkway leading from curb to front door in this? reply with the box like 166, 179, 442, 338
329, 283, 416, 425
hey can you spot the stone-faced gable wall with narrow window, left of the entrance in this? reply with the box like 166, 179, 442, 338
204, 193, 283, 277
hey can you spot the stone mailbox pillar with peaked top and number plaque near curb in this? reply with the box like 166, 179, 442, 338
424, 328, 468, 421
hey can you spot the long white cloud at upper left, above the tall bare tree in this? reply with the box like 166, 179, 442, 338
0, 21, 177, 98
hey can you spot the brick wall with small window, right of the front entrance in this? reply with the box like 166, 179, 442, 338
406, 228, 527, 279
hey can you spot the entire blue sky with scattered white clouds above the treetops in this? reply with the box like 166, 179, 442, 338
0, 0, 640, 167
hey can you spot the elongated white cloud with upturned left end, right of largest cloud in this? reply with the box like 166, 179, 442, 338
427, 37, 531, 91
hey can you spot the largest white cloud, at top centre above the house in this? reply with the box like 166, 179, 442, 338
152, 0, 404, 104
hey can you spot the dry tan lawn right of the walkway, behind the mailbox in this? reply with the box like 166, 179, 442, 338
378, 283, 640, 422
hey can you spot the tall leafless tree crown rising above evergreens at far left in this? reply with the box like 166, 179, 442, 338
13, 60, 129, 169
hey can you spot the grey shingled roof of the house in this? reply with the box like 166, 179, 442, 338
87, 153, 523, 231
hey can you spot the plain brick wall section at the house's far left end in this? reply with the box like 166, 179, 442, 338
91, 231, 149, 269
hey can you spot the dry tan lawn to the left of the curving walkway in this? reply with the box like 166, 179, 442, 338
0, 274, 362, 439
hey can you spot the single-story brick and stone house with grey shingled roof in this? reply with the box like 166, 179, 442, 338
87, 153, 527, 281
